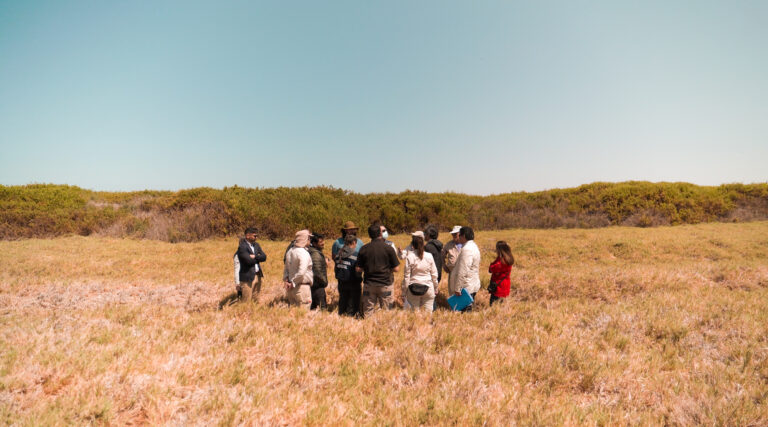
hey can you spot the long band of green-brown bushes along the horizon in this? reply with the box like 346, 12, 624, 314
0, 181, 768, 242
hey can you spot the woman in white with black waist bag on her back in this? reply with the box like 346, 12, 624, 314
403, 231, 437, 313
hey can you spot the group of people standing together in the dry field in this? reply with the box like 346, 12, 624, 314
228, 221, 515, 317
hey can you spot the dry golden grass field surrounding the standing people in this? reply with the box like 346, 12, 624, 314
0, 222, 768, 426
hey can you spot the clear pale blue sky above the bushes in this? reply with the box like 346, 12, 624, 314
0, 0, 768, 194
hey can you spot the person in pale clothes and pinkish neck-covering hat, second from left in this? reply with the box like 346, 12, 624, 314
283, 230, 313, 310
